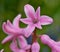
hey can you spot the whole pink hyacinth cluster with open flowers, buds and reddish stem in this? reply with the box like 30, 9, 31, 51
2, 4, 57, 52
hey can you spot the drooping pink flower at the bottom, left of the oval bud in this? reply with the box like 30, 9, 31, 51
10, 36, 31, 52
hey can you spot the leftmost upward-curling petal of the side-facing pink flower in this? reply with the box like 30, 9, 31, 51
2, 22, 16, 35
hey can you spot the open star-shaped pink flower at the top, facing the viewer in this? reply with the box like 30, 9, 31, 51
20, 4, 53, 31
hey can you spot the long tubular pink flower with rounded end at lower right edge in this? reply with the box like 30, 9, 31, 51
40, 35, 60, 52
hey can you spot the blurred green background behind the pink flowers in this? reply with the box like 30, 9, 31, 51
0, 0, 60, 52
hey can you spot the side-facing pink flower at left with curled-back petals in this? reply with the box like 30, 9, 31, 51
2, 15, 34, 44
